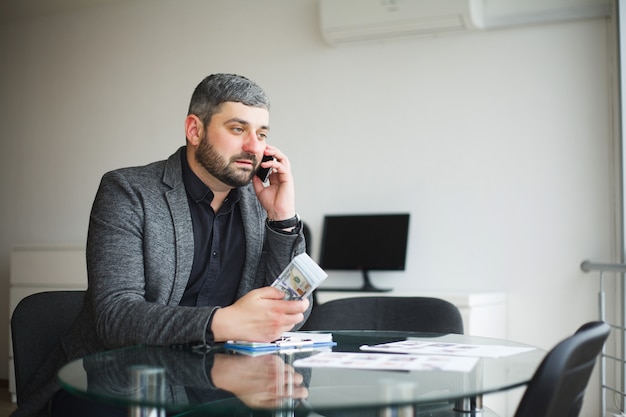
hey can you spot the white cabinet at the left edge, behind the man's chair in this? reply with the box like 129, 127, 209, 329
9, 245, 87, 402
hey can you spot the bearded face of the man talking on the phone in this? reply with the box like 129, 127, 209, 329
196, 102, 269, 187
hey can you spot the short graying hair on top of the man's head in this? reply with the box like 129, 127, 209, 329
187, 74, 270, 126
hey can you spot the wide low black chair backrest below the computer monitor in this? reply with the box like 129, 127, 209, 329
302, 296, 463, 334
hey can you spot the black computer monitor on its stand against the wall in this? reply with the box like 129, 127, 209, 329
320, 213, 409, 292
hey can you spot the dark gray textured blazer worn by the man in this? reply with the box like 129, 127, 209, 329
14, 147, 310, 417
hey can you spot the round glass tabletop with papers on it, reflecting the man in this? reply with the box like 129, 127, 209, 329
59, 331, 546, 414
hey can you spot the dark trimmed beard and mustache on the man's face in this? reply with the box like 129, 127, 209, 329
196, 134, 257, 187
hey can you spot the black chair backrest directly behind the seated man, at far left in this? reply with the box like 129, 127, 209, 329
11, 291, 85, 404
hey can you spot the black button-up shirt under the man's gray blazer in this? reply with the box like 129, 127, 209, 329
180, 152, 246, 306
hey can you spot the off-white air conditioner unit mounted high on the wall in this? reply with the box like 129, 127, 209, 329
319, 0, 474, 45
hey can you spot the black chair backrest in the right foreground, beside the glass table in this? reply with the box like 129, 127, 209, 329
515, 321, 611, 417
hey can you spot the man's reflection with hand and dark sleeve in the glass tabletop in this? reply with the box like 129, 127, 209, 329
75, 347, 310, 415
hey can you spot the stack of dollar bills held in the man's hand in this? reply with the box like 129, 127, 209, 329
272, 253, 328, 300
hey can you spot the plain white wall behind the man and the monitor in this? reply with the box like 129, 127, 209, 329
0, 0, 617, 415
